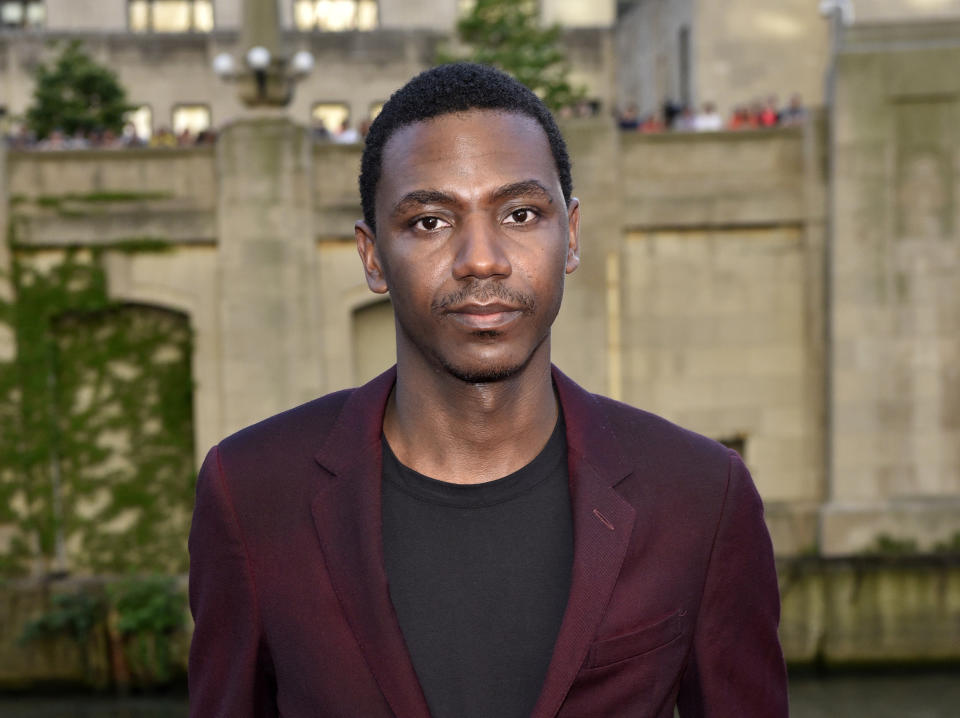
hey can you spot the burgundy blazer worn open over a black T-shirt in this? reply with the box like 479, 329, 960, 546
189, 369, 787, 718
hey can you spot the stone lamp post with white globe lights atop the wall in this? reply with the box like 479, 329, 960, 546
213, 0, 314, 107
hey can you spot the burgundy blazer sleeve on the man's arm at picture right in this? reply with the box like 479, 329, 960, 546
678, 451, 788, 718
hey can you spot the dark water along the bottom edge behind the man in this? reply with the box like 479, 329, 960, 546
0, 671, 960, 718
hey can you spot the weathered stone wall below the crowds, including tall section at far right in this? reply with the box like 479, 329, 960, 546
3, 26, 960, 572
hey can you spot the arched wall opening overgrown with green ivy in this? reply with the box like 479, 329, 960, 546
50, 304, 196, 573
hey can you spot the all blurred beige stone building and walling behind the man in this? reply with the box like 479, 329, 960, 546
0, 0, 960, 580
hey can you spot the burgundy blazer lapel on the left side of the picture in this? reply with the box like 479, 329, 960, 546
311, 369, 430, 718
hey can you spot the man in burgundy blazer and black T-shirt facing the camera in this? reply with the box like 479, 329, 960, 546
190, 64, 787, 718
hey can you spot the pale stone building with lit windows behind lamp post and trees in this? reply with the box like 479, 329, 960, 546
0, 0, 615, 135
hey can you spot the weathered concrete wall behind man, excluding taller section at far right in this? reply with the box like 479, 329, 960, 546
0, 124, 823, 555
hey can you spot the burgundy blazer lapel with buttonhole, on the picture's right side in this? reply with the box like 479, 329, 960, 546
532, 367, 636, 718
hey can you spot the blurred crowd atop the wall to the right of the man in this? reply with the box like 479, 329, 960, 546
617, 94, 807, 132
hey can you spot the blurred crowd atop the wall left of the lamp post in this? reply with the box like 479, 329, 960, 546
6, 122, 217, 150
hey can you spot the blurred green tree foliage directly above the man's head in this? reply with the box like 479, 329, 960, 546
437, 0, 584, 111
